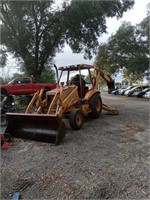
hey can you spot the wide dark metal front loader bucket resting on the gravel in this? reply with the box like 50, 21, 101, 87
5, 113, 66, 144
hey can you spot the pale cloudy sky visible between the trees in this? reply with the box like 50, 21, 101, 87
1, 0, 149, 79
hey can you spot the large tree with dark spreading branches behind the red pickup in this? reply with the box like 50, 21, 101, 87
0, 0, 134, 79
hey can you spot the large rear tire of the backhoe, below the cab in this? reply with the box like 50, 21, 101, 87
89, 94, 102, 119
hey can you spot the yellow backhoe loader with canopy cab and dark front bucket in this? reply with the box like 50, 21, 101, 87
5, 64, 119, 144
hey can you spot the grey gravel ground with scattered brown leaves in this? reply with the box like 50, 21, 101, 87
0, 93, 150, 200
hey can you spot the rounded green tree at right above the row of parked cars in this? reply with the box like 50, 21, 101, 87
95, 17, 149, 80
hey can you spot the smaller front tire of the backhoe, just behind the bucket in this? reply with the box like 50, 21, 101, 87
69, 109, 84, 130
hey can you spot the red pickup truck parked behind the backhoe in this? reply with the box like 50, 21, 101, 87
0, 77, 57, 95
